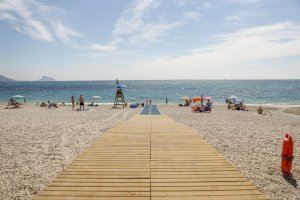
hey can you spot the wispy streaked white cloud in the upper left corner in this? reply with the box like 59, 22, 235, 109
0, 0, 81, 45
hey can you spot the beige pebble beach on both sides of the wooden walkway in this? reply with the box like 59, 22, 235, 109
0, 104, 300, 199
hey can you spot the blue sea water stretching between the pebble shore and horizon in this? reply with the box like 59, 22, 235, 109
0, 80, 300, 104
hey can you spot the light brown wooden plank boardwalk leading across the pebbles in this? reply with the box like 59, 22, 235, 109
37, 115, 266, 200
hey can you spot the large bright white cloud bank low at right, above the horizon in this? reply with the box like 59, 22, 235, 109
136, 21, 300, 78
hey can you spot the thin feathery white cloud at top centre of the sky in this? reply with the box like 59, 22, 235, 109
113, 0, 210, 44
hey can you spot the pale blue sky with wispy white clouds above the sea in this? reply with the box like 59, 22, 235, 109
0, 0, 300, 80
